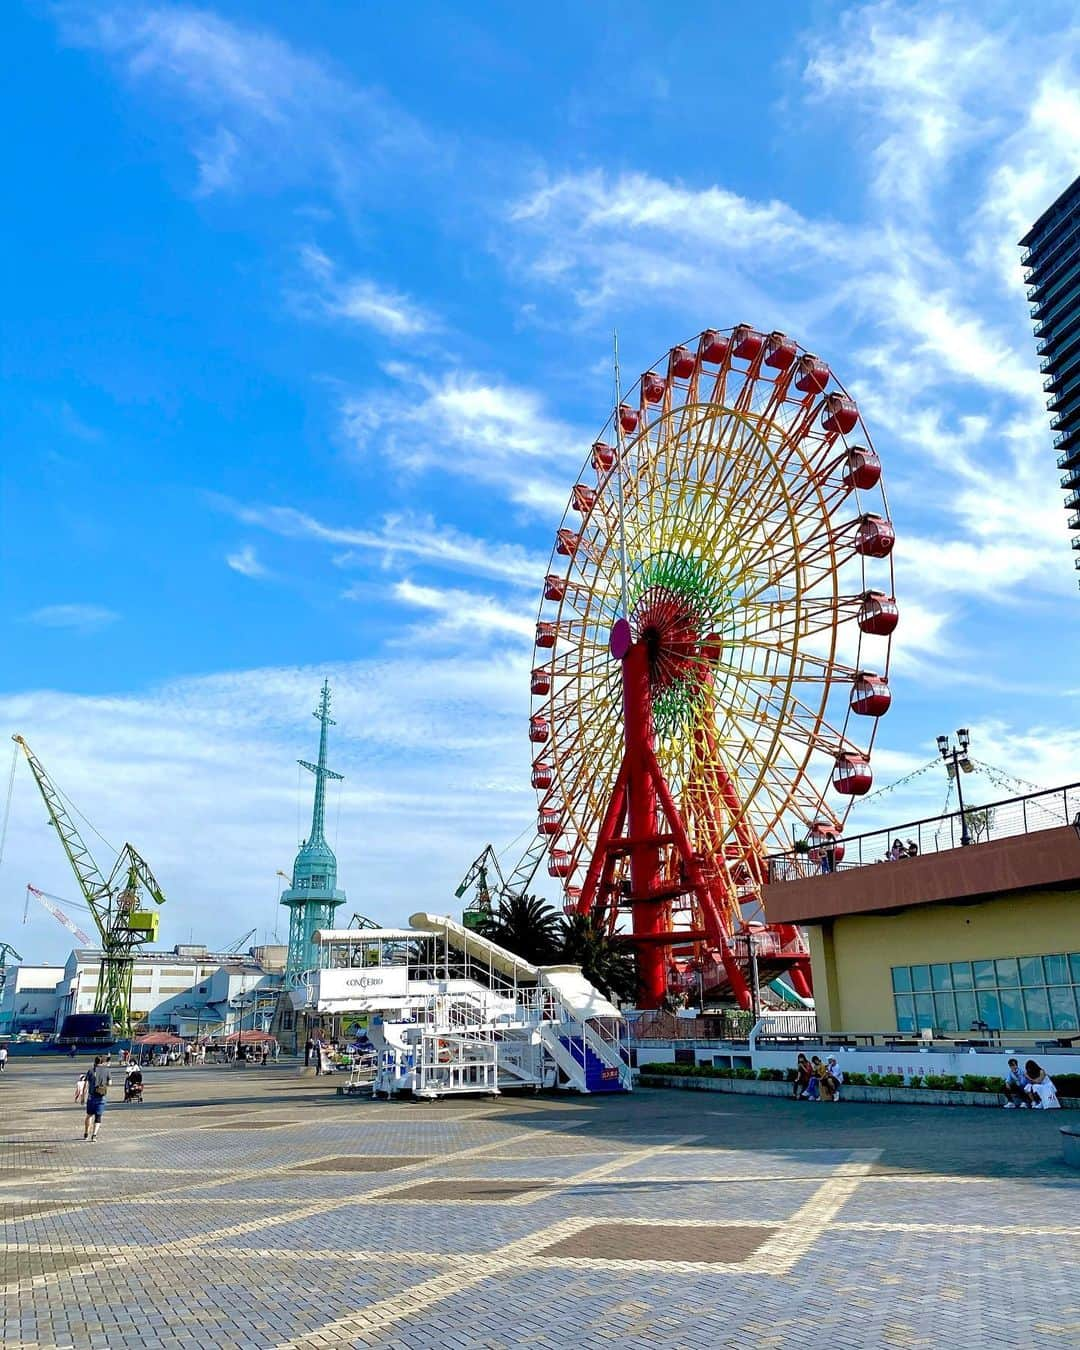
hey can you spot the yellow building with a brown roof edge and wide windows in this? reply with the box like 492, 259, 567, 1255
765, 826, 1080, 1046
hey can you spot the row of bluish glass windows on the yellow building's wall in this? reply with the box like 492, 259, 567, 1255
891, 952, 1080, 1031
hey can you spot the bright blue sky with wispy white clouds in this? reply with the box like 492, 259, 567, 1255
0, 0, 1080, 959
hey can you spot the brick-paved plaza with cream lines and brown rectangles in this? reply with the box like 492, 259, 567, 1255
0, 1060, 1080, 1350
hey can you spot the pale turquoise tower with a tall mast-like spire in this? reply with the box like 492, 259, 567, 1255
281, 680, 346, 987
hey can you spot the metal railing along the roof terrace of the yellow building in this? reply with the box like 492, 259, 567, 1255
767, 783, 1080, 882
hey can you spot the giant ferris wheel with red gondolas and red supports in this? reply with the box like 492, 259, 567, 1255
529, 325, 898, 1002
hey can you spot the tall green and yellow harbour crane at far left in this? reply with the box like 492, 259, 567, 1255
12, 736, 165, 1035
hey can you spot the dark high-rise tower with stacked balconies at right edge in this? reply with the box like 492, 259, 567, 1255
1021, 170, 1080, 591
